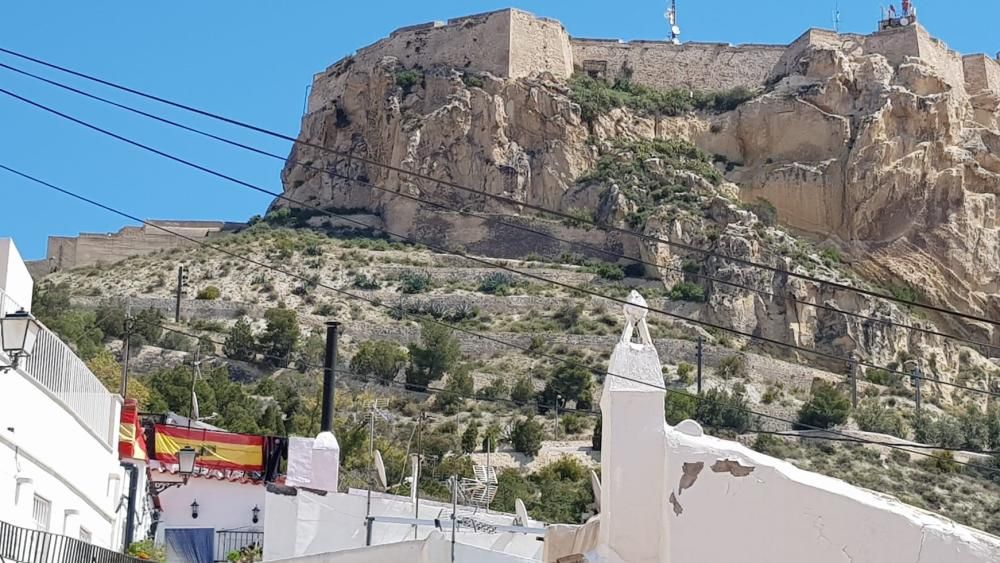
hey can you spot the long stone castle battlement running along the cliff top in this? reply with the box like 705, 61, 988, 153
310, 9, 1000, 111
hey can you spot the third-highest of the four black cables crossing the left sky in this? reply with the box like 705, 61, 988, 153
0, 88, 1000, 397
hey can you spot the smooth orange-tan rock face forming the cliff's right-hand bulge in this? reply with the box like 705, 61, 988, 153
694, 39, 1000, 343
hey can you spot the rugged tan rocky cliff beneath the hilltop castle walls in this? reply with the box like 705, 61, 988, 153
283, 20, 1000, 400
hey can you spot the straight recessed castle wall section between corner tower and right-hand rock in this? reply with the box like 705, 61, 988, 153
571, 39, 786, 90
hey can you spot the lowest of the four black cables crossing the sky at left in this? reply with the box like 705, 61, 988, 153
11, 164, 1000, 475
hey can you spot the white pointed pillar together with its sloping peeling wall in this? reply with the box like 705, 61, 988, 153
580, 298, 1000, 563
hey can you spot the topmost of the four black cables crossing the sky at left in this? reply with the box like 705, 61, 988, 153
0, 47, 1000, 332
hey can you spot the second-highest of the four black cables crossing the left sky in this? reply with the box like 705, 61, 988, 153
0, 58, 1000, 356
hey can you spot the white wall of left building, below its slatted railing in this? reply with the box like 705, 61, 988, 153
0, 366, 127, 549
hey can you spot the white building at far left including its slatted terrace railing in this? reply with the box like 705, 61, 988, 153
0, 239, 138, 563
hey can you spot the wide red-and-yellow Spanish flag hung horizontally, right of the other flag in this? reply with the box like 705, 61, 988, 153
153, 424, 264, 472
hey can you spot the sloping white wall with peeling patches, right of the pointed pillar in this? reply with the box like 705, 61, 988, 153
667, 422, 1000, 563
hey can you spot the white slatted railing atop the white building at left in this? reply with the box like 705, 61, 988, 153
0, 289, 119, 448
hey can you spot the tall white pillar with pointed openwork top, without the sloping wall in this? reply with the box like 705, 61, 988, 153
590, 291, 669, 563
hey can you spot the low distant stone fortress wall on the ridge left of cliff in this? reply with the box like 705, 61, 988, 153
28, 221, 245, 278
